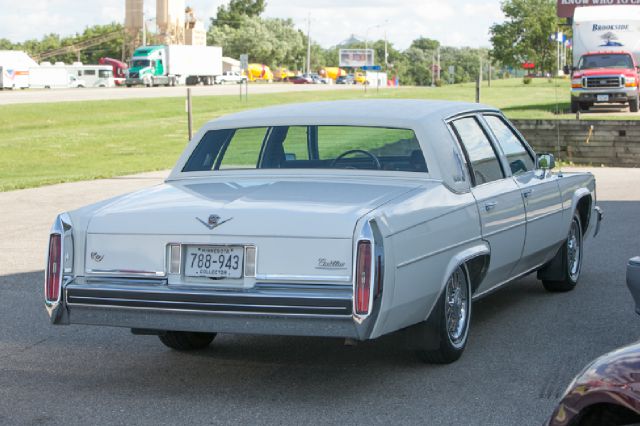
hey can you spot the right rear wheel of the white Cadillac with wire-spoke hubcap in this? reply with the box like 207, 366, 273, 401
418, 266, 471, 364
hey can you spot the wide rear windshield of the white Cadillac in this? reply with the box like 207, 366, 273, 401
182, 126, 427, 172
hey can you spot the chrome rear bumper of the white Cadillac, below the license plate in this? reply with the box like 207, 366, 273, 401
57, 278, 374, 340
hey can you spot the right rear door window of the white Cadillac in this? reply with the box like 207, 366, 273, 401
452, 117, 504, 185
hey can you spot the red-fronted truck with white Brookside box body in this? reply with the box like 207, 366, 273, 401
571, 5, 640, 113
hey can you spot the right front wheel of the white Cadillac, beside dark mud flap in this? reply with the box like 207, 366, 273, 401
542, 213, 582, 292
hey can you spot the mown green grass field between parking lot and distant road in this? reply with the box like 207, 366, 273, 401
0, 79, 640, 191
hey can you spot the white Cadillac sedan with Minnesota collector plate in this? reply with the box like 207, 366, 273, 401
45, 100, 602, 363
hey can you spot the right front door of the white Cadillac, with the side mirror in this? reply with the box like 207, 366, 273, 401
483, 114, 564, 273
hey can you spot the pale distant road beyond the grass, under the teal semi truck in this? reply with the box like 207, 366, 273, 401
0, 83, 364, 105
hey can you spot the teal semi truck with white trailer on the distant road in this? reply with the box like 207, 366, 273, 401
125, 45, 222, 87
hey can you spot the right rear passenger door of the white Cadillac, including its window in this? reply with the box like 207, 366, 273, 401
450, 115, 525, 294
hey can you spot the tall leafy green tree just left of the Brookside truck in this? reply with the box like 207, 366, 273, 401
490, 0, 559, 71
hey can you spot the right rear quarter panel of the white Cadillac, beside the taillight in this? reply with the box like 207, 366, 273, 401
371, 183, 488, 337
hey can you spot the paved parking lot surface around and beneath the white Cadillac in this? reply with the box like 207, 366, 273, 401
0, 169, 640, 425
